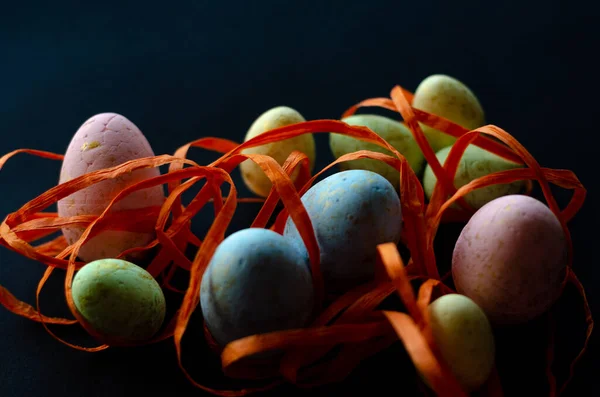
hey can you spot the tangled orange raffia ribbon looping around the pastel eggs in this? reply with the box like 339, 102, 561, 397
0, 82, 593, 396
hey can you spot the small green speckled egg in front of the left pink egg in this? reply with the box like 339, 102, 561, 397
72, 258, 166, 343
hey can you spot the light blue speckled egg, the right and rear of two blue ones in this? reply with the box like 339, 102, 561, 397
284, 170, 402, 292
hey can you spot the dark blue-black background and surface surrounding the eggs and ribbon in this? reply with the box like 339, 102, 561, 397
0, 1, 600, 397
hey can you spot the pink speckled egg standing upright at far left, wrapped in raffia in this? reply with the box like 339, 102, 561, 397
58, 113, 165, 262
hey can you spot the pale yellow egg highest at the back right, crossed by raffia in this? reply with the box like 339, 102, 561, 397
412, 74, 485, 152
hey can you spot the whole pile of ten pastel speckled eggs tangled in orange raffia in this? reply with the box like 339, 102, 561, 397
58, 75, 567, 390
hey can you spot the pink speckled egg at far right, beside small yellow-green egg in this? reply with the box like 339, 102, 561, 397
452, 195, 568, 324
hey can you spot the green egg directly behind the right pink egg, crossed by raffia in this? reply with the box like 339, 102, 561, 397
423, 145, 525, 209
